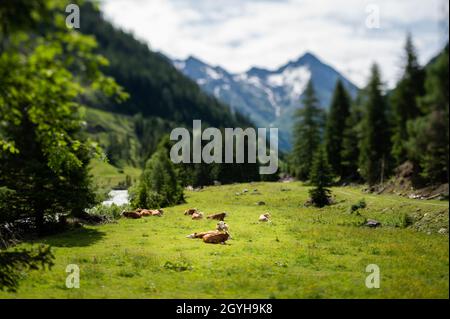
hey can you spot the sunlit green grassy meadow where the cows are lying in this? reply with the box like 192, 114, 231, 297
0, 183, 449, 298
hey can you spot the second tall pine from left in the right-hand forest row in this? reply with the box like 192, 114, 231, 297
325, 80, 350, 178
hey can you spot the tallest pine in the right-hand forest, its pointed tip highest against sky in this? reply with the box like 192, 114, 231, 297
391, 35, 425, 165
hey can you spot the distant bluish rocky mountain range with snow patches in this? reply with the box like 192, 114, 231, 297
173, 53, 358, 150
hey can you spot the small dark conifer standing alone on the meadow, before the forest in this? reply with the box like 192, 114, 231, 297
309, 147, 333, 207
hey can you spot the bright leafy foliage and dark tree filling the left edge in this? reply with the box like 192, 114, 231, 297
0, 1, 126, 230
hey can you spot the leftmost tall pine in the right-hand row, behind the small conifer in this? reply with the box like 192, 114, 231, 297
291, 81, 325, 180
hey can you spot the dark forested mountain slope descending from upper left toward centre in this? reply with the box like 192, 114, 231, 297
81, 3, 250, 127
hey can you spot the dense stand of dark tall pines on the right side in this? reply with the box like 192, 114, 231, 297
288, 35, 449, 188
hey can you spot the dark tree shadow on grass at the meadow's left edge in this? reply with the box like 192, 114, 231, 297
39, 228, 105, 247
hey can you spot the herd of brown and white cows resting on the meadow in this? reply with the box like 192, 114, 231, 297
122, 208, 270, 244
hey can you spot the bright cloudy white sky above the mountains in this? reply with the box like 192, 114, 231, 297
102, 0, 448, 86
